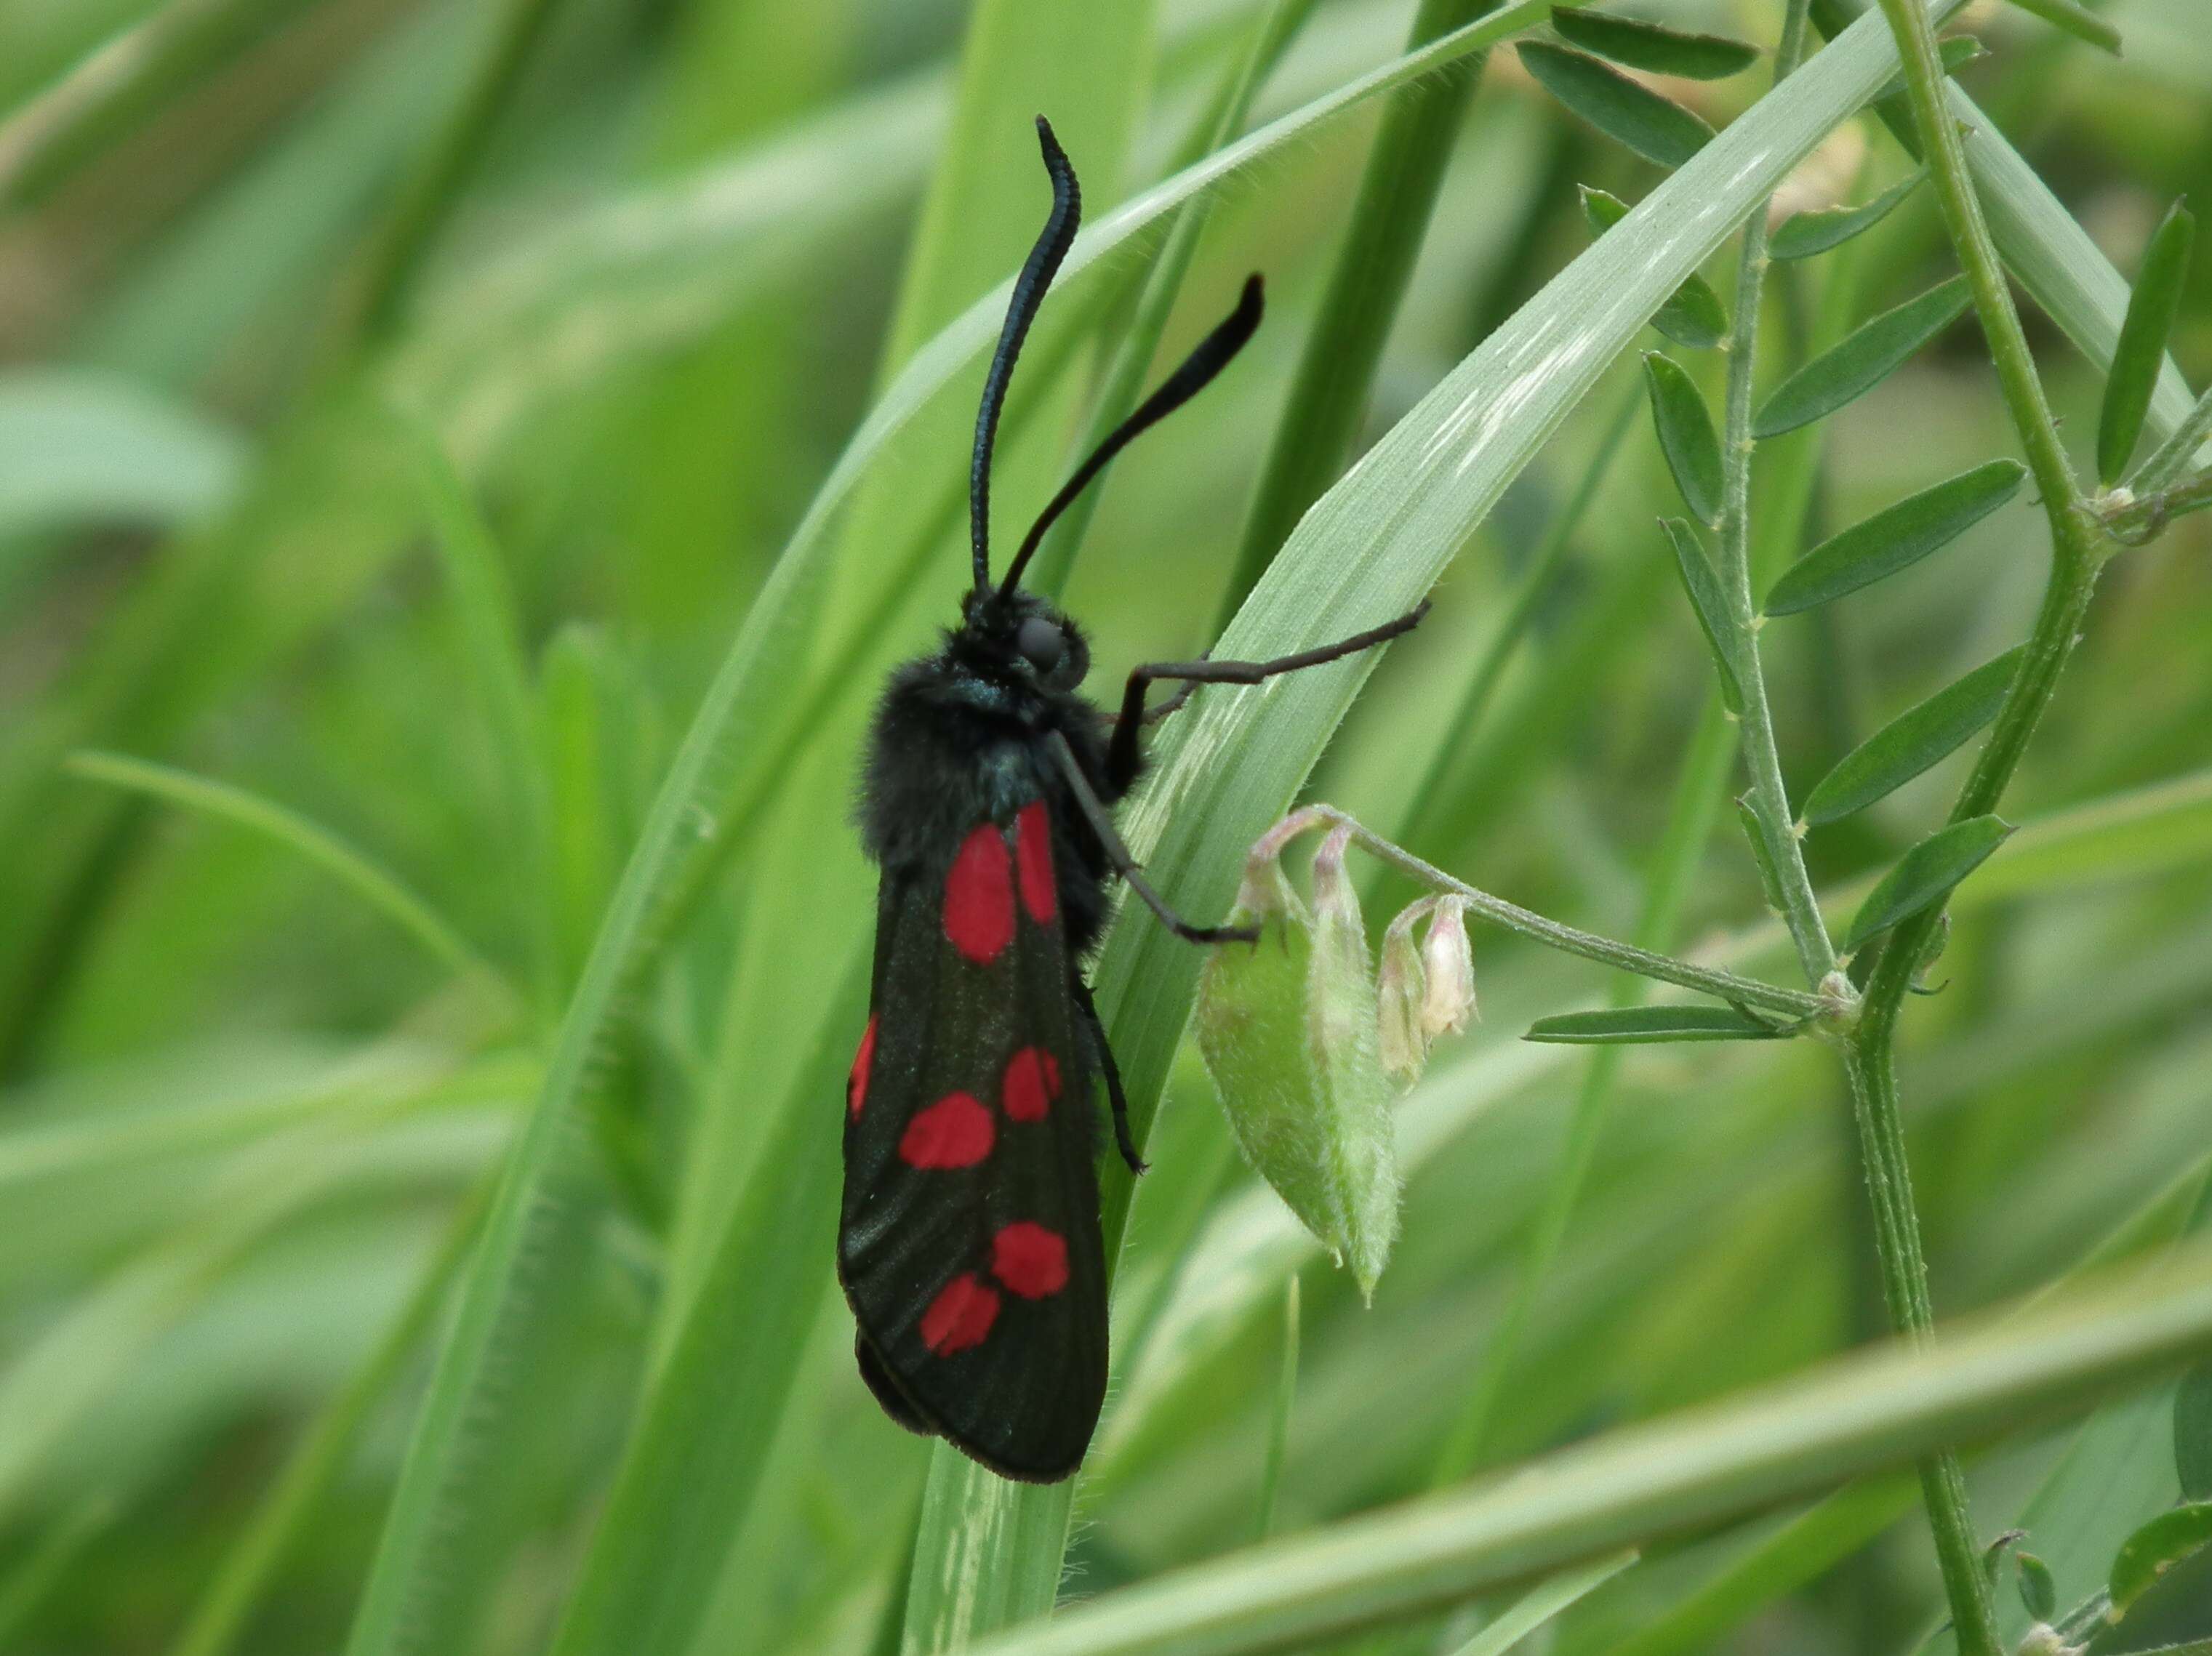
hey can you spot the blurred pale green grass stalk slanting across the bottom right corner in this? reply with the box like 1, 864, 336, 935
976, 1249, 2212, 1656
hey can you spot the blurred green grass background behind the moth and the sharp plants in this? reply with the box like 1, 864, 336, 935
0, 0, 2212, 1656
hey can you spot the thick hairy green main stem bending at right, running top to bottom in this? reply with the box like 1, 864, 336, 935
1845, 0, 2099, 1656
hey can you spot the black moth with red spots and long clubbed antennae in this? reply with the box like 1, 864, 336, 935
838, 117, 1420, 1484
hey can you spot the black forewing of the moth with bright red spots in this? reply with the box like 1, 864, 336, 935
838, 800, 1106, 1482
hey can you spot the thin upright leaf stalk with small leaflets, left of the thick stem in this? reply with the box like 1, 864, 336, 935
1719, 0, 1836, 984
